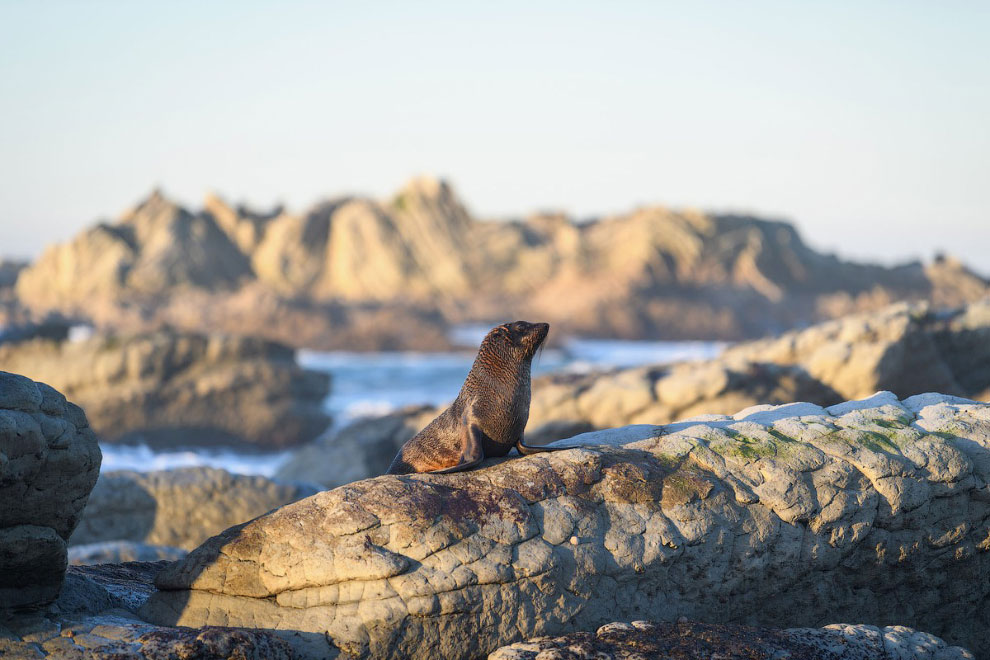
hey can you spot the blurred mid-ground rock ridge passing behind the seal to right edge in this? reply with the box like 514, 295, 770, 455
277, 300, 990, 488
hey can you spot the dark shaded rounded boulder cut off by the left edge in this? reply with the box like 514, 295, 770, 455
0, 371, 102, 609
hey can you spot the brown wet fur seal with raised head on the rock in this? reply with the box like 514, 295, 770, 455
386, 321, 559, 474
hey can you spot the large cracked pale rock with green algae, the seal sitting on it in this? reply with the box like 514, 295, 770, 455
142, 393, 990, 658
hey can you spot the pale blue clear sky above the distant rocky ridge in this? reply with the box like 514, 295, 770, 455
0, 0, 990, 274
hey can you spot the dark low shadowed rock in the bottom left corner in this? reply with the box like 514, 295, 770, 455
0, 562, 292, 660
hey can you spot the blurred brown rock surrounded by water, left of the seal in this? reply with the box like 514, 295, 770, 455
0, 331, 330, 447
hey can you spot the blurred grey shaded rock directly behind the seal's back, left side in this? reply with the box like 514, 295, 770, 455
276, 406, 439, 488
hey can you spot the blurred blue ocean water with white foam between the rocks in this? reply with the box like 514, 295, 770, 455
102, 336, 724, 476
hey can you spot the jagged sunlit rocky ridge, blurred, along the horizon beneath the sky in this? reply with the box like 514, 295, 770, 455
9, 178, 988, 349
